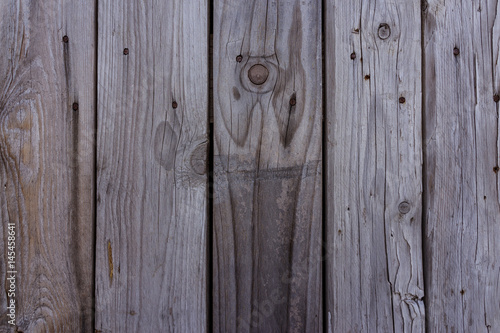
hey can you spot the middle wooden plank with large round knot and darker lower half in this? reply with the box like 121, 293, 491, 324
213, 0, 322, 332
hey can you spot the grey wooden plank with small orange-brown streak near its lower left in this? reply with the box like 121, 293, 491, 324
96, 0, 208, 332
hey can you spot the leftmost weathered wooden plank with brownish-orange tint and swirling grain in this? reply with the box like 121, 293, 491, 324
0, 0, 95, 332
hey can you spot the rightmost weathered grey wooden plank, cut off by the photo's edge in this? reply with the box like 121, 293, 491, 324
424, 0, 500, 332
